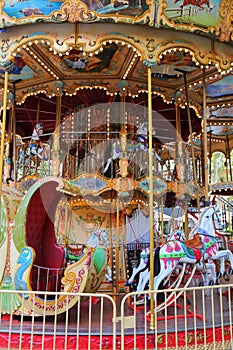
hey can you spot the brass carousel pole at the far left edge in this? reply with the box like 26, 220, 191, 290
0, 71, 9, 200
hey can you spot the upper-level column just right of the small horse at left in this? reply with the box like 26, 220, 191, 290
52, 82, 62, 176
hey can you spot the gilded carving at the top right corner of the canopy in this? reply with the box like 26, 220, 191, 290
215, 0, 233, 41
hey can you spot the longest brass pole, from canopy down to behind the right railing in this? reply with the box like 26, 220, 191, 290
148, 67, 155, 329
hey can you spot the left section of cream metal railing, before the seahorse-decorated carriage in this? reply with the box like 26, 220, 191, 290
0, 290, 117, 350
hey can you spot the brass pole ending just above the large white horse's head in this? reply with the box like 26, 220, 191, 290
202, 68, 209, 201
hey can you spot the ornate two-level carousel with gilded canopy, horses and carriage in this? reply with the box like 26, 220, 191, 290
0, 0, 233, 348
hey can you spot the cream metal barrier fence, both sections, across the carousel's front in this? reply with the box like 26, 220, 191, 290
0, 284, 233, 350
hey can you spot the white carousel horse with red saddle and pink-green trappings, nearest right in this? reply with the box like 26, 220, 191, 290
151, 206, 233, 296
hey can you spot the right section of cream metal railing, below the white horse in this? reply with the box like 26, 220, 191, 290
120, 285, 233, 350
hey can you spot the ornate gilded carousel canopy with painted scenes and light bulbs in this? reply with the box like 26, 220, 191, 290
0, 0, 233, 152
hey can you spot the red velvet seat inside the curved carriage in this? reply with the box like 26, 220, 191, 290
26, 181, 65, 291
